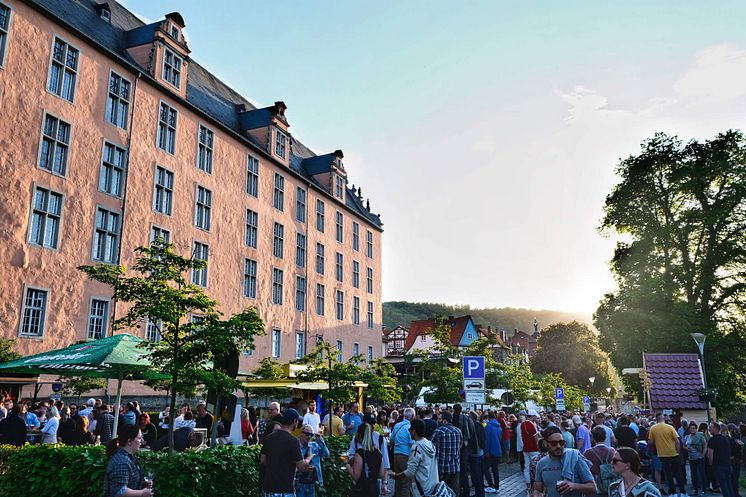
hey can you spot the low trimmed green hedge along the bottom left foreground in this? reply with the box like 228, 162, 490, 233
0, 437, 351, 497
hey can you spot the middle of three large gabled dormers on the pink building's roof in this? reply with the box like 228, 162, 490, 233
241, 101, 291, 166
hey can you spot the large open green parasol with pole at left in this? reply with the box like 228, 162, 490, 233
0, 333, 163, 437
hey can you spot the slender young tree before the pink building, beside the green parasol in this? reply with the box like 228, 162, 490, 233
78, 239, 264, 454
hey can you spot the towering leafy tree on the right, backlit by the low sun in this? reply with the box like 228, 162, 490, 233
595, 131, 746, 408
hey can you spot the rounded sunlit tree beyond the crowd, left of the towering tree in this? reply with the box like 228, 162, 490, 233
531, 321, 612, 392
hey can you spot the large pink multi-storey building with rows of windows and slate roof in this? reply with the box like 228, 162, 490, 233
0, 0, 382, 369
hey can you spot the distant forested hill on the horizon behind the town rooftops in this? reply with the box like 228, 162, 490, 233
383, 301, 593, 331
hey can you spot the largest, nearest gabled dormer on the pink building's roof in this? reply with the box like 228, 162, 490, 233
126, 12, 190, 97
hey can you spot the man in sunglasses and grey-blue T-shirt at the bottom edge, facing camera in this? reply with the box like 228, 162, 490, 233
533, 426, 597, 497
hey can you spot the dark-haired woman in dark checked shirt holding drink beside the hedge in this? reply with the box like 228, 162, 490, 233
104, 424, 153, 497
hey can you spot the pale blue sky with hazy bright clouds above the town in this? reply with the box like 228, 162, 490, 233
128, 0, 746, 313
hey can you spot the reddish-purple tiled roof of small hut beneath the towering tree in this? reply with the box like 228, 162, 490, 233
642, 353, 707, 409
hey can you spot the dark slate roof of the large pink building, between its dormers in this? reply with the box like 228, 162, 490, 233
26, 0, 383, 229
